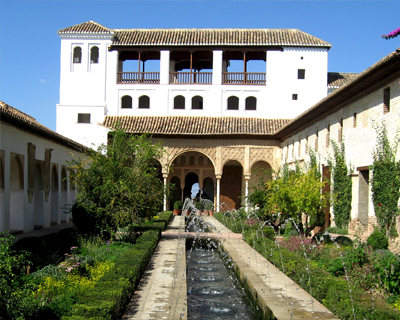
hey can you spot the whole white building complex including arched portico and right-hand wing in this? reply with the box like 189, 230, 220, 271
57, 21, 400, 233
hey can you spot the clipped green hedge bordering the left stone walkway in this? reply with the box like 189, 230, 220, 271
62, 230, 160, 320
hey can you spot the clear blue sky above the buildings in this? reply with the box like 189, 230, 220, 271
0, 0, 400, 130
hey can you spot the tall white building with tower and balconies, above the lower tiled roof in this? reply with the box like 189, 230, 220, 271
57, 21, 331, 145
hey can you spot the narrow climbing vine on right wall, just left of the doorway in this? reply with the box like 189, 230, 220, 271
328, 141, 352, 228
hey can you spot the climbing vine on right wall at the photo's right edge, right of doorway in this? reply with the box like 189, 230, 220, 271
372, 124, 400, 236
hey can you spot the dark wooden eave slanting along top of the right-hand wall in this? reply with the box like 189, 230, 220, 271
275, 48, 400, 141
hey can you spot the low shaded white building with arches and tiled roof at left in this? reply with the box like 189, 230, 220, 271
0, 101, 86, 233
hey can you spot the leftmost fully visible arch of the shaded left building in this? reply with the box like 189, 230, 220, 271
9, 153, 24, 230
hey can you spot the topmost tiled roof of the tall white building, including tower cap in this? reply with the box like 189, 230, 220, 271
58, 21, 332, 48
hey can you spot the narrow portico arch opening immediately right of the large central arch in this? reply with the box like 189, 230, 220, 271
220, 160, 244, 210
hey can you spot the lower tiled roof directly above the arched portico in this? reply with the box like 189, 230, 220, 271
103, 116, 290, 137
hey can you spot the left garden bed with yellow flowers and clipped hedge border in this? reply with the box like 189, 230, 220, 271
0, 212, 172, 320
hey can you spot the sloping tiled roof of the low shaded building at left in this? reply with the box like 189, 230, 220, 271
0, 101, 87, 152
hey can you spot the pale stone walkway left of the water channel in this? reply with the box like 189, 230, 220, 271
122, 216, 187, 320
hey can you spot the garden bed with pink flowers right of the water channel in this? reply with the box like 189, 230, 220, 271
214, 213, 400, 319
